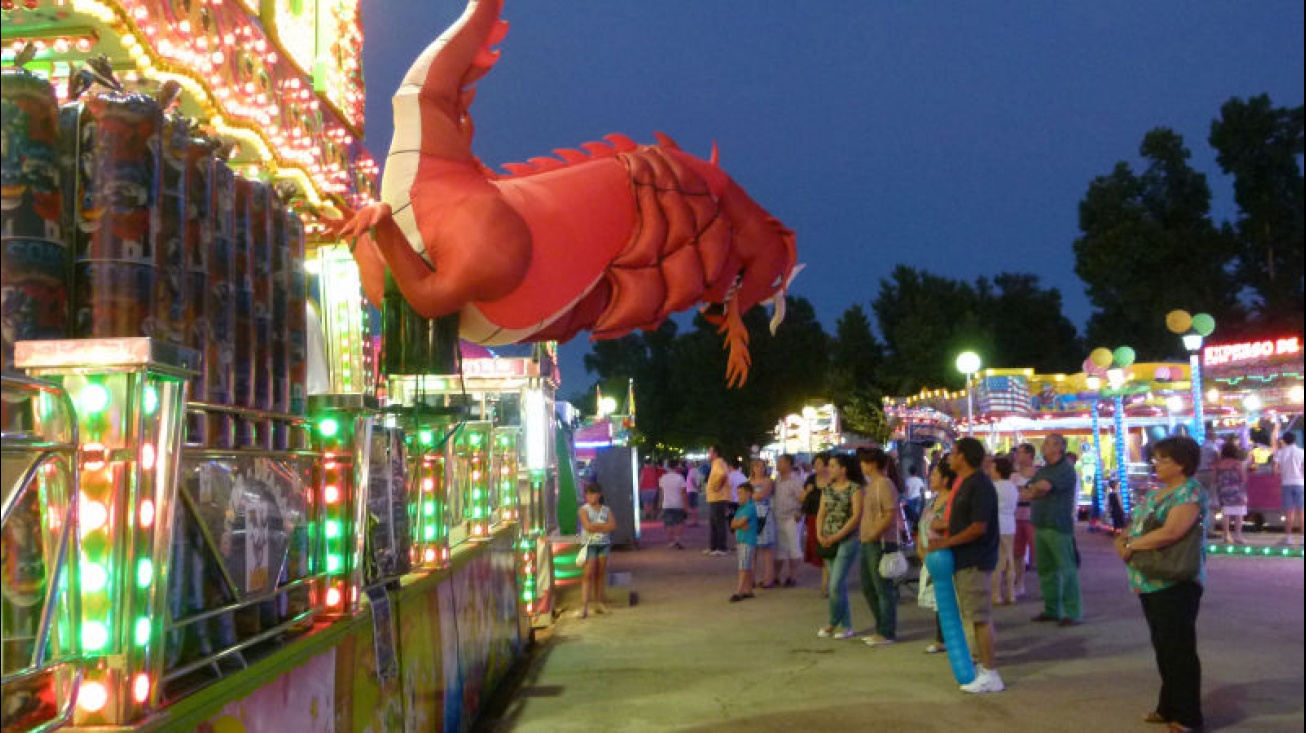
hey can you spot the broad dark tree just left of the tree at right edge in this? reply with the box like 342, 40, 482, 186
1075, 128, 1243, 358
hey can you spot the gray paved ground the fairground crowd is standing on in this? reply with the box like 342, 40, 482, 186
479, 517, 1306, 733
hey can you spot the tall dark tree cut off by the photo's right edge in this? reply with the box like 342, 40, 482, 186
1209, 94, 1306, 333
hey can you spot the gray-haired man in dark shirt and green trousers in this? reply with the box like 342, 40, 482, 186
1020, 432, 1084, 626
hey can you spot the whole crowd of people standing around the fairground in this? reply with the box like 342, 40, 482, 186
581, 432, 1274, 732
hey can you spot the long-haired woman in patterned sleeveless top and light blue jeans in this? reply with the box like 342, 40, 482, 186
816, 453, 865, 639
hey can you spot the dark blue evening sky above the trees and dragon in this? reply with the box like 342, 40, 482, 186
363, 0, 1306, 395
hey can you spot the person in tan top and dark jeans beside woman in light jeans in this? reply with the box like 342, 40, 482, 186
857, 448, 902, 647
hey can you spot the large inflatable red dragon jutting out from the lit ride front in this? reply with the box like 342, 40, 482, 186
338, 0, 797, 385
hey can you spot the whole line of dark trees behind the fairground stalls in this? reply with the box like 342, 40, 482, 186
572, 94, 1306, 453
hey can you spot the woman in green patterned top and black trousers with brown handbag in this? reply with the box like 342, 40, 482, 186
1115, 436, 1207, 733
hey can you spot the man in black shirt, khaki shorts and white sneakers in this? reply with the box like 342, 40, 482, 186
930, 438, 1006, 694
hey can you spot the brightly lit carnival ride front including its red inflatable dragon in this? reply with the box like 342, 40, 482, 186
0, 0, 794, 730
